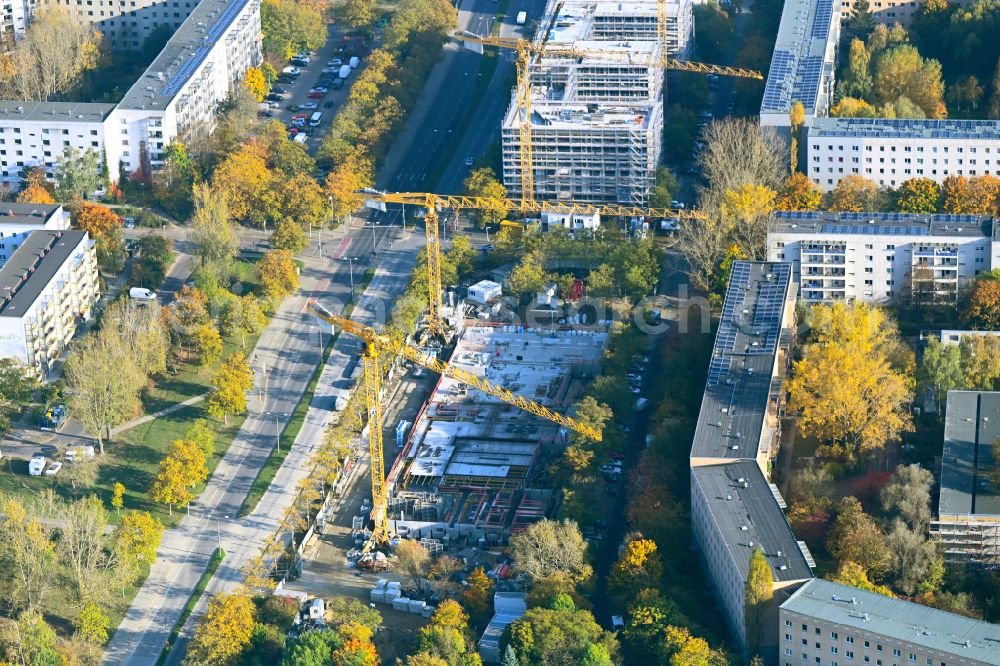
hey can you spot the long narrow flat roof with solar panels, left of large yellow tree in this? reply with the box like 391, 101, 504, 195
691, 261, 791, 460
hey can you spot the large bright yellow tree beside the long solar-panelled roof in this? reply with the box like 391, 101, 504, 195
788, 302, 913, 463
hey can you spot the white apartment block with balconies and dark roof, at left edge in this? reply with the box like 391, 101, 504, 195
0, 231, 100, 378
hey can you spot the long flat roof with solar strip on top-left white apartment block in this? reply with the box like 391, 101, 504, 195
118, 0, 250, 111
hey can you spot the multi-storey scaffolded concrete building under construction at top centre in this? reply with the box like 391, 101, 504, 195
501, 0, 693, 205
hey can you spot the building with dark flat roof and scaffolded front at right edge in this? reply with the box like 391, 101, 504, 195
931, 391, 1000, 564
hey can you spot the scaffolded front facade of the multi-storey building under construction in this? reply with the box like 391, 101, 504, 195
501, 100, 663, 206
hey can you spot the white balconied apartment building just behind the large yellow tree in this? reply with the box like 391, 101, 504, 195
767, 211, 1000, 303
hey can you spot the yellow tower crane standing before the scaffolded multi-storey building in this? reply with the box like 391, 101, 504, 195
455, 33, 764, 201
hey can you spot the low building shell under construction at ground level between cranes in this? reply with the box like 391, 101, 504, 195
388, 326, 607, 543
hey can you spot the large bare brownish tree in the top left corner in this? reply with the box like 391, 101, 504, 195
0, 8, 101, 102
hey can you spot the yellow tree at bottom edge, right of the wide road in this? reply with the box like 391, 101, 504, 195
184, 593, 254, 666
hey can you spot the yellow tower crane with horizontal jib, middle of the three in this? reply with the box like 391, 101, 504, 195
359, 189, 704, 337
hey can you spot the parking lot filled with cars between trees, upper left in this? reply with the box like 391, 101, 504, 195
262, 24, 372, 154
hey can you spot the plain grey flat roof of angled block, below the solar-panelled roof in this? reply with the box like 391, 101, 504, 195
691, 460, 812, 582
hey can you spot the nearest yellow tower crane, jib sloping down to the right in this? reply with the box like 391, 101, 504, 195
309, 301, 601, 552
